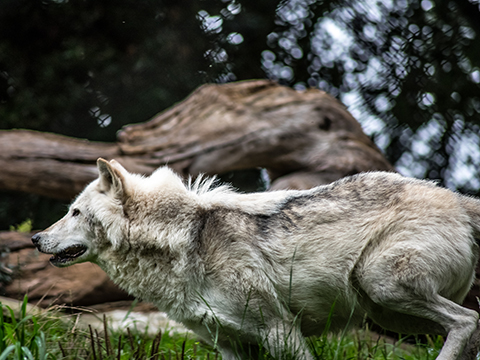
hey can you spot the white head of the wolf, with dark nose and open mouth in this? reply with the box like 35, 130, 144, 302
32, 159, 132, 267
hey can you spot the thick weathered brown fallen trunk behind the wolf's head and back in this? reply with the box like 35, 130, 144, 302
0, 80, 393, 199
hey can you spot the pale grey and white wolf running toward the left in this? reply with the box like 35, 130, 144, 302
32, 159, 480, 360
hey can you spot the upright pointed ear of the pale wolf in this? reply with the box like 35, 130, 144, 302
97, 158, 127, 198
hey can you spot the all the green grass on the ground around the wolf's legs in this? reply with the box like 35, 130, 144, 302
0, 297, 443, 360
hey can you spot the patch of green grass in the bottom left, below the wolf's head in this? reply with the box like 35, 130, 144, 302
0, 296, 218, 360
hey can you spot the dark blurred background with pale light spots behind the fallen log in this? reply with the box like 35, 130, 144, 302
0, 0, 480, 229
